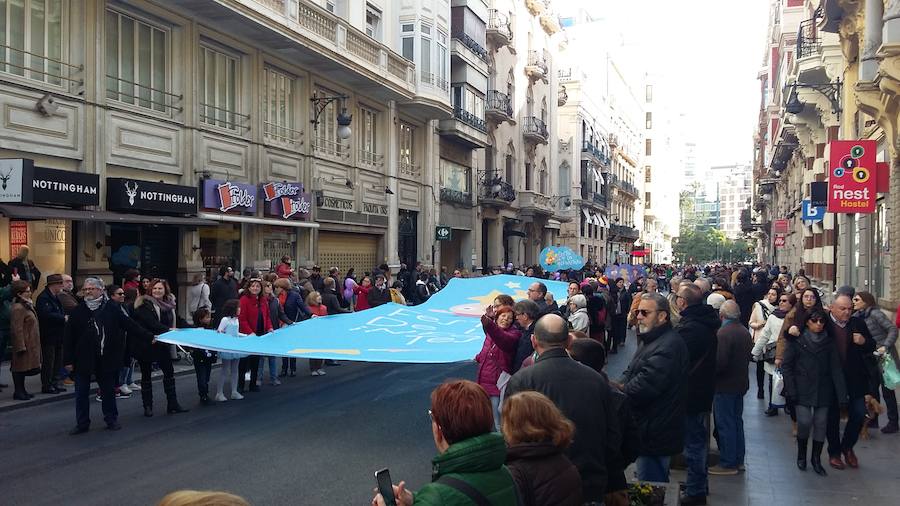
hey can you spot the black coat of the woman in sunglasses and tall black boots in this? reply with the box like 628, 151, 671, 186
781, 330, 847, 408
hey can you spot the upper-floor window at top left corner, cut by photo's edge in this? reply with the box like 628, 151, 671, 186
0, 0, 63, 85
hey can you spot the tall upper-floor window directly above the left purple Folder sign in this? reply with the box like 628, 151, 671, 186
198, 46, 239, 130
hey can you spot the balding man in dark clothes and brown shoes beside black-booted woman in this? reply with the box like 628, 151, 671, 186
825, 295, 881, 469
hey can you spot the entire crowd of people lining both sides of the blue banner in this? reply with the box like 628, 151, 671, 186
0, 249, 900, 506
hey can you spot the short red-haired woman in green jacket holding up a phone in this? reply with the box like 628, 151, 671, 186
372, 380, 518, 506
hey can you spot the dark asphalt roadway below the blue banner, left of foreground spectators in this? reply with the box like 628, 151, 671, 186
0, 360, 475, 506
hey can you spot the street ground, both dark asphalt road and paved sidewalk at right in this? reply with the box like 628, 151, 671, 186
0, 330, 900, 506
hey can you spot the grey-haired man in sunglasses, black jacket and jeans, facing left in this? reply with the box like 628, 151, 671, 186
621, 293, 688, 482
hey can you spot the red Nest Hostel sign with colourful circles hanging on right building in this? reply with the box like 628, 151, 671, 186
828, 140, 877, 213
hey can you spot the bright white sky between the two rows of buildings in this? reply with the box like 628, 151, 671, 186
572, 0, 769, 170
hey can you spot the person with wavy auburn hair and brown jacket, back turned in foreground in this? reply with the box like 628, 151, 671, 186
502, 392, 584, 506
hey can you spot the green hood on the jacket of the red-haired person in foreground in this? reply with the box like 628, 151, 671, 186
431, 432, 506, 481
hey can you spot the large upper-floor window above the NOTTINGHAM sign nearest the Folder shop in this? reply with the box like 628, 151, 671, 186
106, 10, 172, 112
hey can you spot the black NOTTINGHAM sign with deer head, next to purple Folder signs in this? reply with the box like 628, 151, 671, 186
106, 177, 197, 215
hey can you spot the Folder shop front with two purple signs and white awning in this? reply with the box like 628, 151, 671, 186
199, 179, 318, 279
